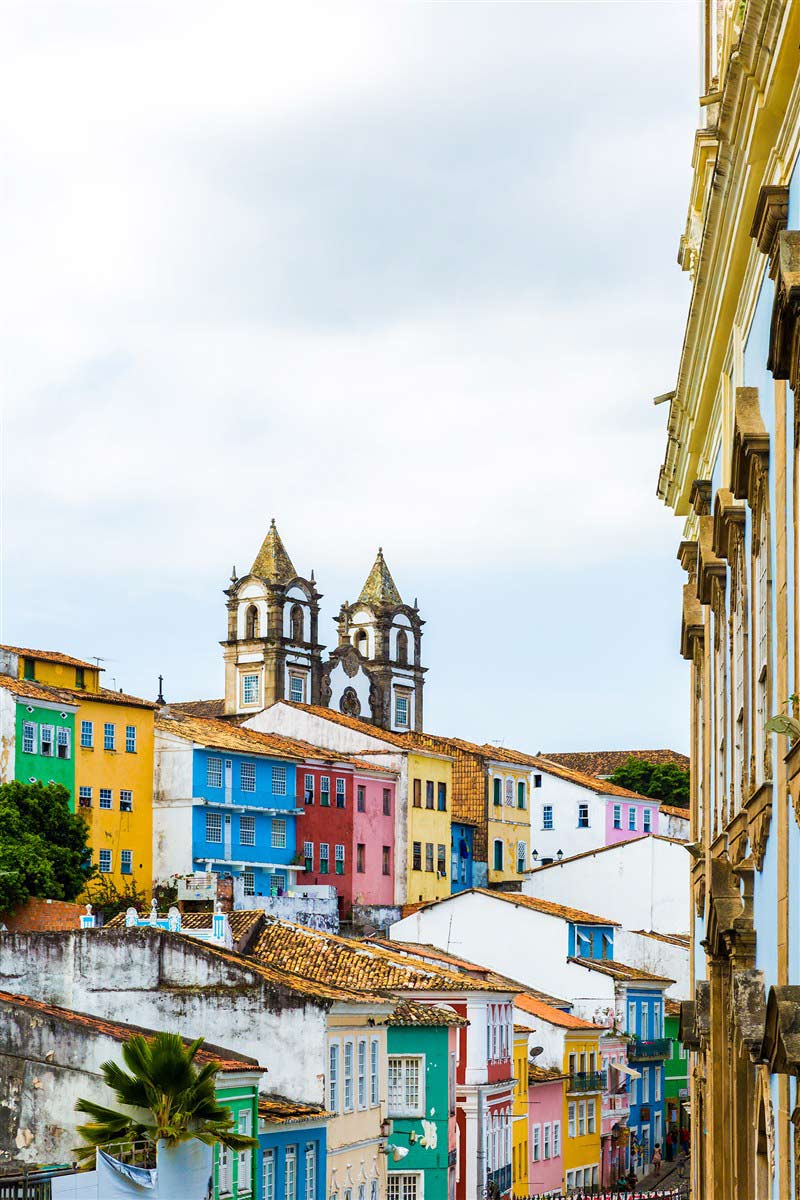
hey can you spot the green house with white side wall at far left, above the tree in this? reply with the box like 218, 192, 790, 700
0, 677, 78, 808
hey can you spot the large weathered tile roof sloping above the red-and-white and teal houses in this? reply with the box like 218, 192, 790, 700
252, 917, 509, 992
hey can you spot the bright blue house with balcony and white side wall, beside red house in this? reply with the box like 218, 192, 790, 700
154, 713, 303, 895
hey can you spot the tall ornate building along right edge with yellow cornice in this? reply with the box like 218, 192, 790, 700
657, 0, 800, 1200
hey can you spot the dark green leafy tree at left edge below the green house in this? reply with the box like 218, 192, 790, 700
0, 782, 95, 912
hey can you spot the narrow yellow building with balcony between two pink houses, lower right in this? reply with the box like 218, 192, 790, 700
564, 1018, 604, 1190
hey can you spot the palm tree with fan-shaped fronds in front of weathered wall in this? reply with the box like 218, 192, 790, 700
76, 1033, 258, 1165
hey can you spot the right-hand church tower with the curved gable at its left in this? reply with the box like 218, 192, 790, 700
321, 550, 426, 733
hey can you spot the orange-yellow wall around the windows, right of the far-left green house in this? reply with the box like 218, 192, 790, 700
76, 696, 154, 892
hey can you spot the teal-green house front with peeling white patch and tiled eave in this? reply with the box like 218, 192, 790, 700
386, 1001, 468, 1200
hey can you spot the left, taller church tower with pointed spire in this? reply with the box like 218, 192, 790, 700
221, 518, 323, 714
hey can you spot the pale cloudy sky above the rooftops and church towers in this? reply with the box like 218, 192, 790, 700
0, 0, 698, 751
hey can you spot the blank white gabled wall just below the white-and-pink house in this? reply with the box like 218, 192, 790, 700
523, 835, 691, 934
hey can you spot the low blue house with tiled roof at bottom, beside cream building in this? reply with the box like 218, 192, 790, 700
255, 1096, 331, 1200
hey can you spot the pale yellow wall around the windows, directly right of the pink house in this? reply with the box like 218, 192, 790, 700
407, 752, 452, 904
